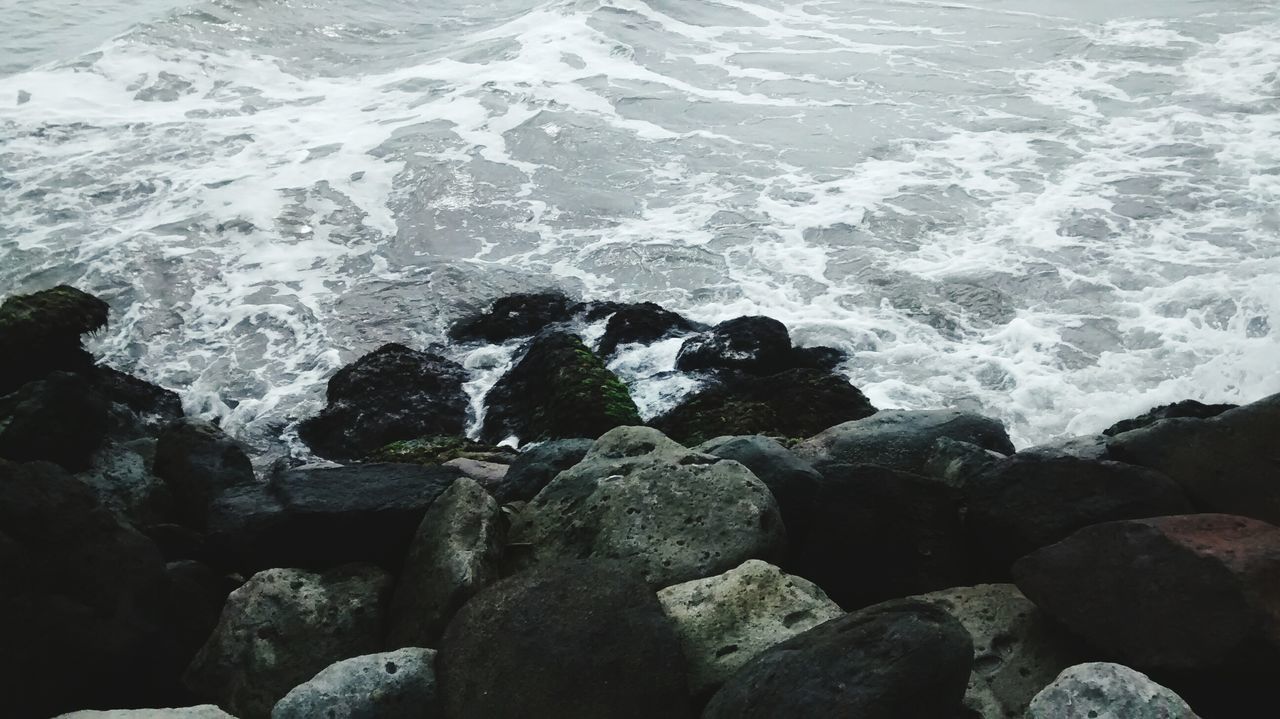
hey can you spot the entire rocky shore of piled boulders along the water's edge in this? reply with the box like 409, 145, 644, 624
0, 287, 1280, 719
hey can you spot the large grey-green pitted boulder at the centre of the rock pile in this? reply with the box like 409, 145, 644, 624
512, 427, 786, 587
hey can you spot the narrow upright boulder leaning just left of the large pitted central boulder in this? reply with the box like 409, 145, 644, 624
388, 477, 507, 647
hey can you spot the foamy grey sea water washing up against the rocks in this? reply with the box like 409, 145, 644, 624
0, 0, 1280, 449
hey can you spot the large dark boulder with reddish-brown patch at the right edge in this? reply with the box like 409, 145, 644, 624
1014, 514, 1280, 672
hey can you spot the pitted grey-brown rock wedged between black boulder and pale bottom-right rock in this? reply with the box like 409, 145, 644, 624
911, 585, 1079, 719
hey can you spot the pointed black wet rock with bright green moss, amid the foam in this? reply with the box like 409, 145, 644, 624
480, 331, 640, 443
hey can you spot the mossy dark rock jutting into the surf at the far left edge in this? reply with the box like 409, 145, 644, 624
0, 285, 109, 394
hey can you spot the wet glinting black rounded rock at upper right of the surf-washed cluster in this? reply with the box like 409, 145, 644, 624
676, 316, 791, 375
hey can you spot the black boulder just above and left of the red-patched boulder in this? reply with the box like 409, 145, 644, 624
965, 454, 1192, 578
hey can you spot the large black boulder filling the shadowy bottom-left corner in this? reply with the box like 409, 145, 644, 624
0, 461, 177, 719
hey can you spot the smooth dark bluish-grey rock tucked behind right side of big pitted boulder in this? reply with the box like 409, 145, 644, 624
694, 435, 822, 546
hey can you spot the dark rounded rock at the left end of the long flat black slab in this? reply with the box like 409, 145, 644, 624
154, 420, 257, 530
